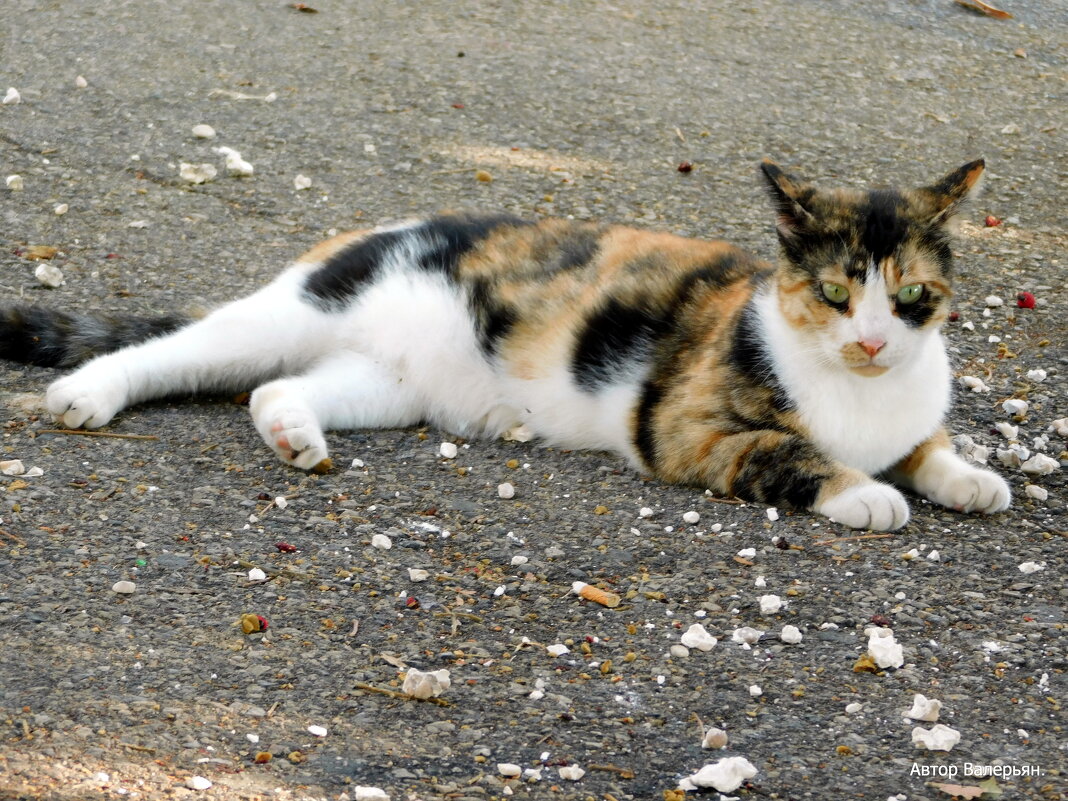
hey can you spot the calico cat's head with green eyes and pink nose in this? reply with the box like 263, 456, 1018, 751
763, 159, 984, 376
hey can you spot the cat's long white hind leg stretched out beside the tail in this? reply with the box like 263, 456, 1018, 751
47, 273, 331, 428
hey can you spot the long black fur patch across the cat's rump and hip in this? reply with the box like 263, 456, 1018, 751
304, 215, 527, 310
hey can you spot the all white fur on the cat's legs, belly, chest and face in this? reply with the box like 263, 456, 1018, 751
47, 225, 1009, 529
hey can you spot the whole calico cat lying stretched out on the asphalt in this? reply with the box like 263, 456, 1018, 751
0, 160, 1009, 530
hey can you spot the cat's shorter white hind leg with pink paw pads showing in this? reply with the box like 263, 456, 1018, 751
249, 350, 422, 470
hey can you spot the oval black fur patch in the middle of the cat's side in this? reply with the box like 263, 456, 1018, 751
571, 298, 671, 392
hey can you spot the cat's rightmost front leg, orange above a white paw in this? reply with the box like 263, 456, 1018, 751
890, 430, 1012, 514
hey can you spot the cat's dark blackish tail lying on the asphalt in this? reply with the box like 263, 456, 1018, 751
0, 304, 190, 367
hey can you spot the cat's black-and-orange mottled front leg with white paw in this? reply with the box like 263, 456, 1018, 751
658, 430, 909, 531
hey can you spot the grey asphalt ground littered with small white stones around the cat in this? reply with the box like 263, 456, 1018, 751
0, 0, 1068, 801
